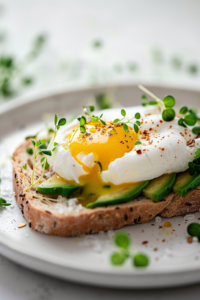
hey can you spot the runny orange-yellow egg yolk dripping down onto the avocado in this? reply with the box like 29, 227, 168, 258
66, 122, 138, 205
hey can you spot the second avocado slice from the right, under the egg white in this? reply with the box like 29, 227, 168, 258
143, 173, 176, 201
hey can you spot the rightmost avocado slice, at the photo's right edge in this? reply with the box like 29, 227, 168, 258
173, 170, 200, 196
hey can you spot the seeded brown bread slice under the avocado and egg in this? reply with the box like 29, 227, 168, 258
13, 139, 200, 236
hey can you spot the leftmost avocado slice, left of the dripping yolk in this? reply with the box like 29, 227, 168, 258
37, 175, 82, 197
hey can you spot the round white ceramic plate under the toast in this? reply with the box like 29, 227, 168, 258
0, 85, 200, 288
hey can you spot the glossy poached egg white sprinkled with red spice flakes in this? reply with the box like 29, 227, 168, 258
48, 107, 200, 185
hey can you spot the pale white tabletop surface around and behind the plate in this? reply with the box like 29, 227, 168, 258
0, 0, 200, 300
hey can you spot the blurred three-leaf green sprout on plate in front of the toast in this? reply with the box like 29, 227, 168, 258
110, 231, 149, 267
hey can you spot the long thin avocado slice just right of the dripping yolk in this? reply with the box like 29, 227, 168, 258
86, 181, 149, 208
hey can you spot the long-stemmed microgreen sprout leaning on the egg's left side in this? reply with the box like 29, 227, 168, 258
24, 114, 67, 192
